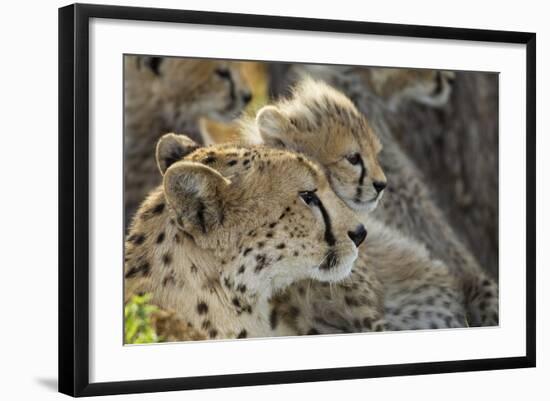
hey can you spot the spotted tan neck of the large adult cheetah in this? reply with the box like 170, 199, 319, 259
126, 196, 270, 338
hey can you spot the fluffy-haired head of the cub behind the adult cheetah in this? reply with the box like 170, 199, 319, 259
256, 79, 386, 212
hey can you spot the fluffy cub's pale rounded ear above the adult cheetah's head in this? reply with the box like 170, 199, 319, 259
256, 106, 293, 148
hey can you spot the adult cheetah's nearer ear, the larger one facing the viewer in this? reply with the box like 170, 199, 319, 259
163, 161, 231, 234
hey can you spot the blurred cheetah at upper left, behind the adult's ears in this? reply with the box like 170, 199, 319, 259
124, 56, 252, 221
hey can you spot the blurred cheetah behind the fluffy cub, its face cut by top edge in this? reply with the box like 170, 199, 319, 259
288, 73, 499, 327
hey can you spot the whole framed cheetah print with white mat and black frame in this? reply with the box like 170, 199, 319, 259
59, 4, 535, 396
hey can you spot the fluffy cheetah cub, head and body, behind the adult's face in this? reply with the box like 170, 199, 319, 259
233, 80, 466, 334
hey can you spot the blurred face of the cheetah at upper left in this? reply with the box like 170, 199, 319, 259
132, 57, 252, 122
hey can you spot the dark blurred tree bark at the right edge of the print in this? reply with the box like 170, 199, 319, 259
388, 72, 499, 277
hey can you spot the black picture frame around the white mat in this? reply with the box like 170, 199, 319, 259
59, 4, 536, 396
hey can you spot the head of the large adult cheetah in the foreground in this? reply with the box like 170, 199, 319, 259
157, 134, 366, 295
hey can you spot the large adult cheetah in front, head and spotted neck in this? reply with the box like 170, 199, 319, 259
125, 134, 366, 339
